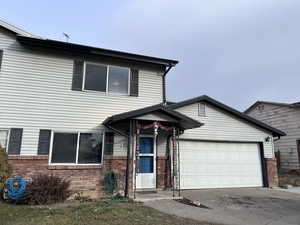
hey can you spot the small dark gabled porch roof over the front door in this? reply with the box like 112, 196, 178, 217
103, 104, 203, 129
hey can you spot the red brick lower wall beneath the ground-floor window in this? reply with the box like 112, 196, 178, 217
9, 156, 126, 197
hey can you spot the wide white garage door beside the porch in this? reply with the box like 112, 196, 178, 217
180, 141, 263, 189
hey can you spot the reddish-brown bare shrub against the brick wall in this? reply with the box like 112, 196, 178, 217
27, 174, 72, 205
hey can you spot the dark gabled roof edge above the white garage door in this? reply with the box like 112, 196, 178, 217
168, 95, 286, 137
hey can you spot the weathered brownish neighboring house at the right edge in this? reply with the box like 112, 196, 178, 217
245, 101, 300, 169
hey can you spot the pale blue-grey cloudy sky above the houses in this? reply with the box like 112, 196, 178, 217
0, 0, 300, 111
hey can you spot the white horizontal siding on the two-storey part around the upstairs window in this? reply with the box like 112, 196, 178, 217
0, 28, 162, 155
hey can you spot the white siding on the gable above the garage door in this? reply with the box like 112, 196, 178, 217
176, 103, 274, 158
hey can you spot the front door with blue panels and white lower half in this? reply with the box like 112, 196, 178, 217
136, 137, 156, 188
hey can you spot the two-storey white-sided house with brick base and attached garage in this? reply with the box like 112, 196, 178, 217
0, 20, 284, 198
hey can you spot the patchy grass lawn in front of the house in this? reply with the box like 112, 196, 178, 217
0, 202, 217, 225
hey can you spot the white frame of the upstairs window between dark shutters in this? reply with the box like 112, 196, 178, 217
81, 61, 131, 96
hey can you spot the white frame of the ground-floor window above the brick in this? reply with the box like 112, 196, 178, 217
48, 130, 106, 166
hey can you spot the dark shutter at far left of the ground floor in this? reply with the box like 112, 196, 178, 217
7, 128, 23, 155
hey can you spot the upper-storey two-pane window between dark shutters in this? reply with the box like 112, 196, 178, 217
83, 63, 130, 94
